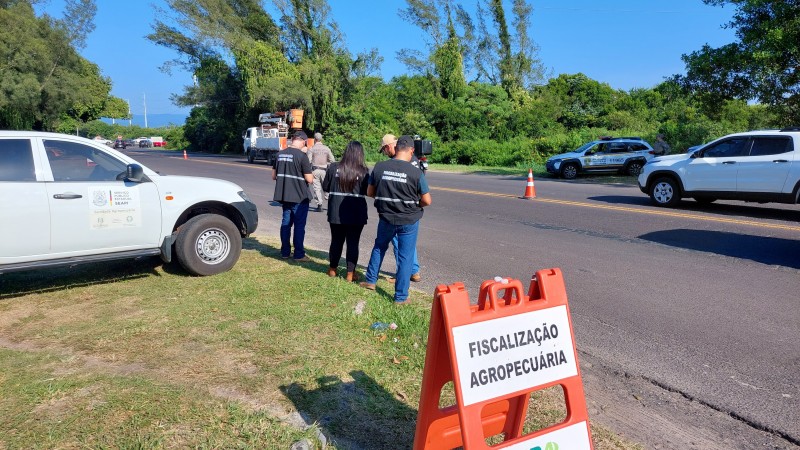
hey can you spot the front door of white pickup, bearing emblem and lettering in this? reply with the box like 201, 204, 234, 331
39, 138, 161, 257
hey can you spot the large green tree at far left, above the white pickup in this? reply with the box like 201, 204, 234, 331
0, 0, 111, 130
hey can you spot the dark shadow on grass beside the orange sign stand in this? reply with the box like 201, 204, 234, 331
280, 371, 417, 450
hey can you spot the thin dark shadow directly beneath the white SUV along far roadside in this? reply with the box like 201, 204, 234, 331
588, 195, 800, 223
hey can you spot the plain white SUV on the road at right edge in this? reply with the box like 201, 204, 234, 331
638, 127, 800, 206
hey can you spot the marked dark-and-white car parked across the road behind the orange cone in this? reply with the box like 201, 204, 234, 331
545, 137, 654, 180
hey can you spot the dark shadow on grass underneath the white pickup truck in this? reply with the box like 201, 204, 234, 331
0, 257, 162, 299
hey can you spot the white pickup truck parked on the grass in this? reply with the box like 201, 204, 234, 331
0, 131, 258, 275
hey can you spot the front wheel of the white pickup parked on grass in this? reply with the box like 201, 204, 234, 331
175, 214, 242, 276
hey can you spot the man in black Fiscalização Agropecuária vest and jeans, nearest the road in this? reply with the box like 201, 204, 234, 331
361, 136, 431, 305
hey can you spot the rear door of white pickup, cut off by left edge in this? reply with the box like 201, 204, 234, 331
0, 137, 50, 264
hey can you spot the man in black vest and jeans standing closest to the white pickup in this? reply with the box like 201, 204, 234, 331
272, 130, 314, 262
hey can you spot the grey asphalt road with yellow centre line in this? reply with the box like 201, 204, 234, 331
131, 150, 800, 448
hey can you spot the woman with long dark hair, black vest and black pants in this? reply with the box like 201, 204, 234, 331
322, 141, 369, 281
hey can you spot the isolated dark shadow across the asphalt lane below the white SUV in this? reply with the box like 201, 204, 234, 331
639, 229, 800, 269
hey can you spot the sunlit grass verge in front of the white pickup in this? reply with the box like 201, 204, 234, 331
0, 238, 634, 449
